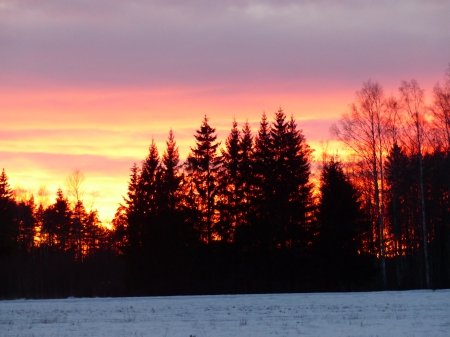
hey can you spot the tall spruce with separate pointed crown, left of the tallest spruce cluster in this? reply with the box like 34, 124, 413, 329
187, 116, 222, 243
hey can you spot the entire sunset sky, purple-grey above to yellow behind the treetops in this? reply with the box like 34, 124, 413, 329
0, 0, 450, 221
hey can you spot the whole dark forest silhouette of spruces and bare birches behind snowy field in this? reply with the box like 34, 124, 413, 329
0, 67, 450, 298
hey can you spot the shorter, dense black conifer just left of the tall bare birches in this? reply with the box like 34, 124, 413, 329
316, 158, 370, 290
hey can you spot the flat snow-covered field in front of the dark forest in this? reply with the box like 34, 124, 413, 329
0, 290, 450, 337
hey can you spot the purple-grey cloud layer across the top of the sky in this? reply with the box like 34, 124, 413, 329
0, 0, 450, 89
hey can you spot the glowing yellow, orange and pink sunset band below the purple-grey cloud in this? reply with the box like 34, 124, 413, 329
0, 86, 347, 222
